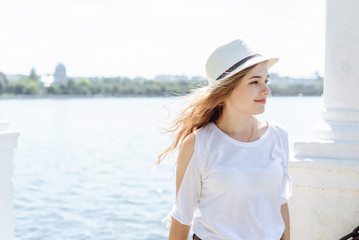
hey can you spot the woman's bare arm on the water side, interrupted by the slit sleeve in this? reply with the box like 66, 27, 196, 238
169, 133, 196, 240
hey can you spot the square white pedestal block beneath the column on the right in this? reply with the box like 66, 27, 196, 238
288, 155, 359, 240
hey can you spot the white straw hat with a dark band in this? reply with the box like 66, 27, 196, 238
206, 39, 279, 84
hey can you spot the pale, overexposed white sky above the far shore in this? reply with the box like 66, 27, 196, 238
0, 0, 325, 78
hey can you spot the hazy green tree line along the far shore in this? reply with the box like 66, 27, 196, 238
0, 69, 323, 96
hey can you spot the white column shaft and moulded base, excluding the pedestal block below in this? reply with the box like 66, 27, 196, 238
294, 0, 359, 160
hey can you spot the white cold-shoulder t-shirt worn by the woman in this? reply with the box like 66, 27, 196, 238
163, 121, 292, 240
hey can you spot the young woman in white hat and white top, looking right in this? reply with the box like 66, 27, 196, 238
159, 40, 292, 240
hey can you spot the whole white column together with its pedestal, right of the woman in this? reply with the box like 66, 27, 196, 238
289, 0, 359, 240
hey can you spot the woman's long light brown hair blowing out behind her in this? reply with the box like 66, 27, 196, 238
157, 65, 256, 164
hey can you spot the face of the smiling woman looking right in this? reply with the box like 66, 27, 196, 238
225, 62, 271, 115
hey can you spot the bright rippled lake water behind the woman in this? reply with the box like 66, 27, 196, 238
0, 97, 323, 240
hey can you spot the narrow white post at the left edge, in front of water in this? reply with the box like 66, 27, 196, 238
0, 121, 19, 240
